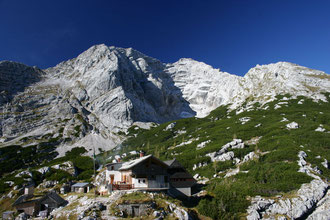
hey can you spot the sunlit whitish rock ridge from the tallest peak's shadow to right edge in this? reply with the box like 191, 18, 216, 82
166, 59, 330, 117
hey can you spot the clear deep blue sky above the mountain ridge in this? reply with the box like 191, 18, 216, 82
0, 0, 330, 75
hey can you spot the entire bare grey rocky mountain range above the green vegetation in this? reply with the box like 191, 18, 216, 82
0, 44, 330, 156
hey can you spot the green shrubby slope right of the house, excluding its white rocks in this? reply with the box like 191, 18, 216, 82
116, 94, 330, 218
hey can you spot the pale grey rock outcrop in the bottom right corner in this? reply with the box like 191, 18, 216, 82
247, 151, 329, 220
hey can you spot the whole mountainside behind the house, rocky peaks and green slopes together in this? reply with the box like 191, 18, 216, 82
0, 45, 330, 220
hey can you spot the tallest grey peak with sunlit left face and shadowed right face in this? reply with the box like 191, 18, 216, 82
46, 45, 195, 130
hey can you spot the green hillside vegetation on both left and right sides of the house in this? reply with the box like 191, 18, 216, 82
0, 93, 330, 219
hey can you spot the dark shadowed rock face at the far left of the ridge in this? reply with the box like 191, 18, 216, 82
0, 61, 44, 105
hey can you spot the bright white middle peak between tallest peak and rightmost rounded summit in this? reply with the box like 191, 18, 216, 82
166, 59, 246, 117
